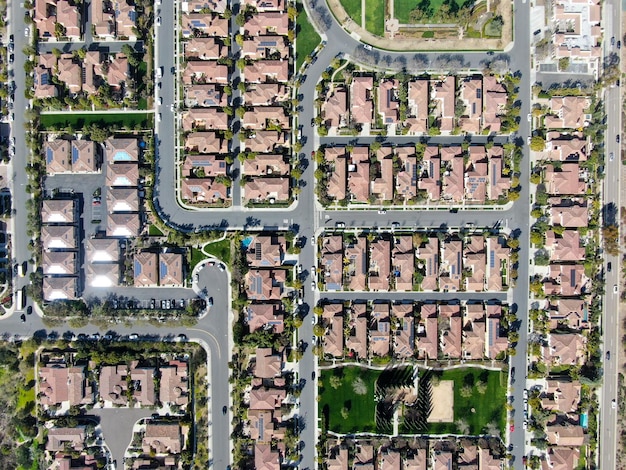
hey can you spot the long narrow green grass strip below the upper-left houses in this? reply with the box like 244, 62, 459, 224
41, 112, 152, 129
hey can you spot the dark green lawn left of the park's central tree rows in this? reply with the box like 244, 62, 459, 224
319, 367, 381, 434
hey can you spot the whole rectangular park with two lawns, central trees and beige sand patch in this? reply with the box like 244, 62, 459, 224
319, 366, 507, 435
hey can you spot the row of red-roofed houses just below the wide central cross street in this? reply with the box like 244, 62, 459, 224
319, 233, 511, 292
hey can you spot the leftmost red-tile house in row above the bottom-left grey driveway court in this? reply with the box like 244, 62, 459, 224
38, 364, 94, 407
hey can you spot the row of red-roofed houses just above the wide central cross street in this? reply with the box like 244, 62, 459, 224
318, 146, 511, 204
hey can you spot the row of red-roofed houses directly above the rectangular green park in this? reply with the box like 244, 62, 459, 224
319, 302, 508, 360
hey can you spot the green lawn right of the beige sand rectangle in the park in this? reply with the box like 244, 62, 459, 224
428, 367, 506, 436
